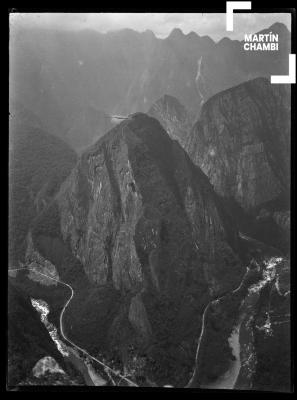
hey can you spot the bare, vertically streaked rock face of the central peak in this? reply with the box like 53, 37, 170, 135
58, 114, 242, 292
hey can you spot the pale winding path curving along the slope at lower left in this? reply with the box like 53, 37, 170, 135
8, 267, 138, 387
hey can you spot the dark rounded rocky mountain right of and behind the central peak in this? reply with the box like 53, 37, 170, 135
185, 78, 290, 252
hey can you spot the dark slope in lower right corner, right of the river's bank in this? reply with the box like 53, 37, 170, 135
252, 260, 293, 392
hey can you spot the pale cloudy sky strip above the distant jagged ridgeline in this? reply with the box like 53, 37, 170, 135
10, 12, 291, 41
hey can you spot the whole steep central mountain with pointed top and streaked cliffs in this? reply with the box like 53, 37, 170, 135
28, 113, 243, 385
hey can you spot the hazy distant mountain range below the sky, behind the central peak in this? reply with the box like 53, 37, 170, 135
10, 24, 290, 151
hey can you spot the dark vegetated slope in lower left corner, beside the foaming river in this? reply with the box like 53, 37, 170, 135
7, 276, 84, 387
